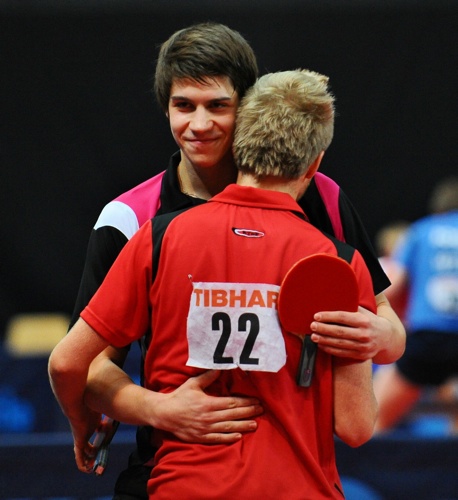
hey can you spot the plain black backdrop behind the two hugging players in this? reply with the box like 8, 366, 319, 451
0, 0, 458, 331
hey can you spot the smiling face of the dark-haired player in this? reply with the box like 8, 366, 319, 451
168, 77, 239, 170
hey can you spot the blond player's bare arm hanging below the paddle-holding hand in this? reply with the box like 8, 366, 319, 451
334, 358, 378, 447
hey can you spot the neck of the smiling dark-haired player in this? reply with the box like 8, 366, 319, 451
178, 156, 236, 200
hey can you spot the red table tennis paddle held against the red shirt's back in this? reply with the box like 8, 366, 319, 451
278, 253, 359, 387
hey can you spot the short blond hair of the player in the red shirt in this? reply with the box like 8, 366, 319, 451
233, 69, 334, 179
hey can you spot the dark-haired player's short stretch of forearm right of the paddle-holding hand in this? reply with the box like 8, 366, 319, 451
373, 293, 406, 365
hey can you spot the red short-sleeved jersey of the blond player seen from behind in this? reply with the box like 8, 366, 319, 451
82, 185, 375, 500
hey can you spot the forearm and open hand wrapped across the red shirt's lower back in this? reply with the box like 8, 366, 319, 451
86, 364, 263, 443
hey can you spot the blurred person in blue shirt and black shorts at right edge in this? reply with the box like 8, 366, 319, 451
374, 177, 458, 433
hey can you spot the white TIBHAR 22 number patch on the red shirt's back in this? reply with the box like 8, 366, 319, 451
187, 282, 286, 372
